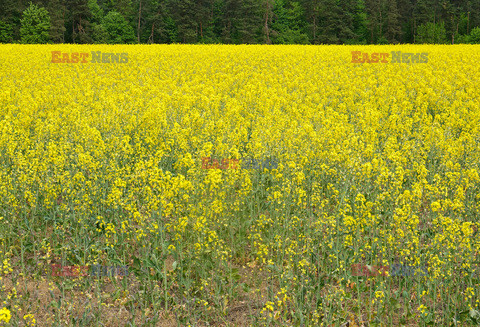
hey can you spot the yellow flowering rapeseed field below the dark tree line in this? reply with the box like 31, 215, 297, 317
0, 45, 480, 326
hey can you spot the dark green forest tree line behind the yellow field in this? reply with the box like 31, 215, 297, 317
0, 0, 480, 44
